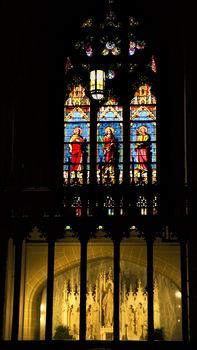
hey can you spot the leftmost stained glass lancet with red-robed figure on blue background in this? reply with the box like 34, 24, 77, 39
64, 85, 90, 185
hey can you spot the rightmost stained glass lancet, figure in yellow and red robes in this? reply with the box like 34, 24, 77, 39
130, 85, 157, 185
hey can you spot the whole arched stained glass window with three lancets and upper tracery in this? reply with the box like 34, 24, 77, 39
64, 1, 157, 193
